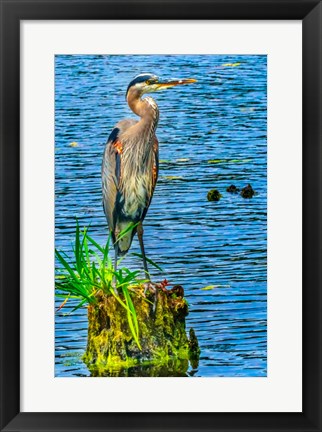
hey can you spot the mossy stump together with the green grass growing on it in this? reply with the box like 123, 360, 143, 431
55, 222, 199, 375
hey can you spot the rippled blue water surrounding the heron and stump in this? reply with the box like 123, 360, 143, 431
55, 55, 267, 377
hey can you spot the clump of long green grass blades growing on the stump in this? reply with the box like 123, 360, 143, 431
55, 221, 161, 349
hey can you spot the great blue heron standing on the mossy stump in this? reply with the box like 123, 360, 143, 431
102, 73, 196, 277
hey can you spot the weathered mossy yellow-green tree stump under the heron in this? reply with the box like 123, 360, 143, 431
84, 284, 199, 376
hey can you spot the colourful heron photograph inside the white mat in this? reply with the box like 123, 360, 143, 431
53, 54, 269, 378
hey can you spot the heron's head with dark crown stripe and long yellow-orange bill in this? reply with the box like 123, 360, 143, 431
126, 73, 197, 96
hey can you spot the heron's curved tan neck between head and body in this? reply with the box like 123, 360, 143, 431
127, 89, 159, 138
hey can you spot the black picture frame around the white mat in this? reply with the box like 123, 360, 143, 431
0, 0, 322, 432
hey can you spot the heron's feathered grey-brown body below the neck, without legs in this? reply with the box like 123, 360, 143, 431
102, 120, 159, 255
